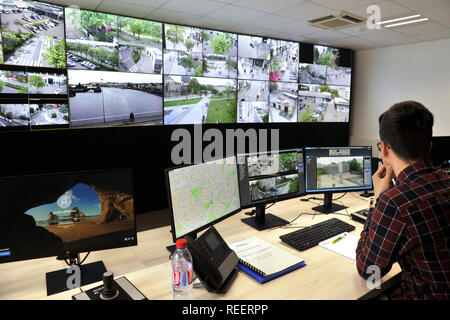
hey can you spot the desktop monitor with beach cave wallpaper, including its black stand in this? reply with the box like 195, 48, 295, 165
0, 169, 137, 295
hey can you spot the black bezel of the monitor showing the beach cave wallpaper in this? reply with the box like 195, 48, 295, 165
0, 168, 138, 264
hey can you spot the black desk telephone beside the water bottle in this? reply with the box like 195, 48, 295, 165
184, 227, 239, 293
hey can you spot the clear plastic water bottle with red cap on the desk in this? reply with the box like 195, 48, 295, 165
171, 239, 194, 300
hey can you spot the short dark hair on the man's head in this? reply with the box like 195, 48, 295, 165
378, 101, 434, 161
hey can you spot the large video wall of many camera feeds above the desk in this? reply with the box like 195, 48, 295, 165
0, 0, 351, 130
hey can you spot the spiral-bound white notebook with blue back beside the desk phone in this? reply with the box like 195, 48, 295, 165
228, 237, 306, 283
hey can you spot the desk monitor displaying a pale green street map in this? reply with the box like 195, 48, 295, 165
166, 157, 241, 241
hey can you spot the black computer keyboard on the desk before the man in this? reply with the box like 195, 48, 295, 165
280, 218, 355, 251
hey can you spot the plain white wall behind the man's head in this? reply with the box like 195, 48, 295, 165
350, 39, 450, 156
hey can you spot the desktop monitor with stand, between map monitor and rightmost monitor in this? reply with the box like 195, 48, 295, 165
237, 148, 305, 230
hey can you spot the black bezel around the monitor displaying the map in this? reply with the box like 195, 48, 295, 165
164, 155, 242, 243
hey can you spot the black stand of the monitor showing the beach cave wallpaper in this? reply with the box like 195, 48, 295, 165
45, 254, 106, 296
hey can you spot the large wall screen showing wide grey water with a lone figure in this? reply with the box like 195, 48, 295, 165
69, 70, 163, 127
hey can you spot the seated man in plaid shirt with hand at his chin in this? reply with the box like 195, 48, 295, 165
356, 101, 450, 300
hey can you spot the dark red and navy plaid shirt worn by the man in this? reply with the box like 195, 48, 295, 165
356, 161, 450, 299
